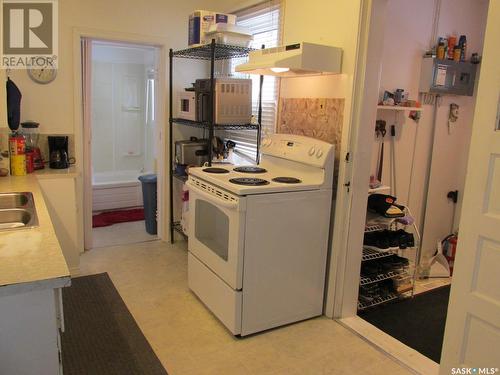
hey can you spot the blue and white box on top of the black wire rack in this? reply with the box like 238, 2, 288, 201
188, 10, 236, 47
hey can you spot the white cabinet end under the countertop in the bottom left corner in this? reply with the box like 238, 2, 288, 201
0, 289, 64, 375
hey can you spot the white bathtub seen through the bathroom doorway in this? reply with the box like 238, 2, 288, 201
92, 171, 147, 211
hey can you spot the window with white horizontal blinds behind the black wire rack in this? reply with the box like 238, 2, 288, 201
218, 1, 282, 160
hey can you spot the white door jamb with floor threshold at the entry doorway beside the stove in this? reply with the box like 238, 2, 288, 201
325, 0, 444, 375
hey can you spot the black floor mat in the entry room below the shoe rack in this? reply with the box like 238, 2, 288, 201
358, 285, 450, 363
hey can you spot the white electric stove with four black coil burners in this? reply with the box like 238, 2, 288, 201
187, 134, 334, 336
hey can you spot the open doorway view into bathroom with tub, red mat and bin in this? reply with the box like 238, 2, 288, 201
86, 40, 159, 248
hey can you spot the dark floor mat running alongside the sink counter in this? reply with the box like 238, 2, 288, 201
61, 273, 167, 375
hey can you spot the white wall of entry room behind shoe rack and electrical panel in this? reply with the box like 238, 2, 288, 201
372, 0, 488, 260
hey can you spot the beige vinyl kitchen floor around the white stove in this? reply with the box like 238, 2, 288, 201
80, 241, 410, 375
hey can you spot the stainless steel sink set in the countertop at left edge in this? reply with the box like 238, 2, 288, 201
0, 192, 38, 231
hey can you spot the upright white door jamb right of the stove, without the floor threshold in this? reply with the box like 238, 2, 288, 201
325, 0, 387, 318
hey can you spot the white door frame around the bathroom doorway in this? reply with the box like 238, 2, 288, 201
73, 28, 170, 249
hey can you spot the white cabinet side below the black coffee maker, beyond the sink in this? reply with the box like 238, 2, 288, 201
38, 175, 80, 275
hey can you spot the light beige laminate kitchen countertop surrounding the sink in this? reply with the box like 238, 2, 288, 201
0, 174, 73, 296
